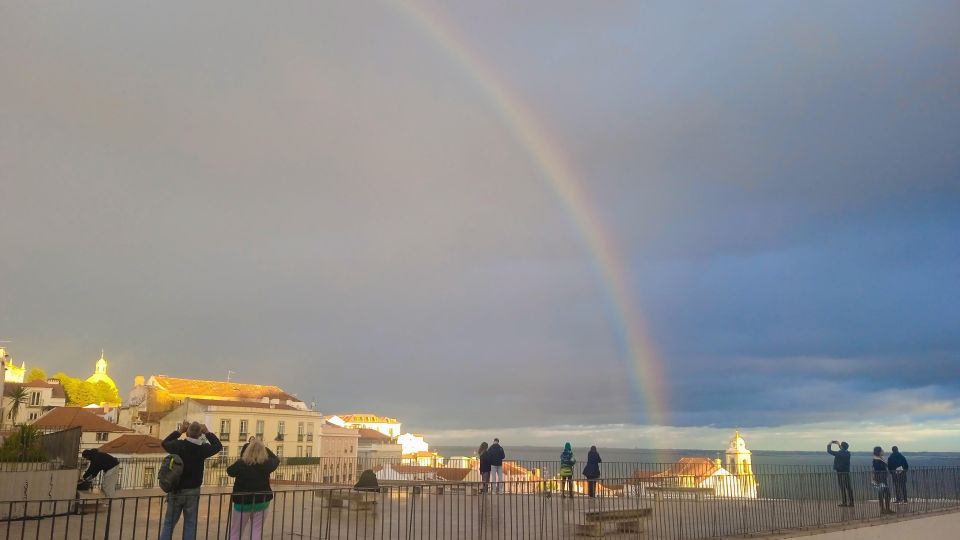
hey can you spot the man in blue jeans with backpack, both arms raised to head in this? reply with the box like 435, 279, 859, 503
160, 422, 223, 540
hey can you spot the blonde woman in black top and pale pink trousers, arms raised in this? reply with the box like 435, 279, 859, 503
227, 439, 280, 540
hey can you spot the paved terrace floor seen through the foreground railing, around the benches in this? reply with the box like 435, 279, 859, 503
0, 484, 960, 540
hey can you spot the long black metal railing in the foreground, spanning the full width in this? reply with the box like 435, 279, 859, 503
0, 468, 960, 540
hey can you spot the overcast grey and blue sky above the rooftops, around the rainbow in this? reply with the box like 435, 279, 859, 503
0, 0, 960, 450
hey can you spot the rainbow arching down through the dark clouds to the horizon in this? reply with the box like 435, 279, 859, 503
389, 0, 666, 425
